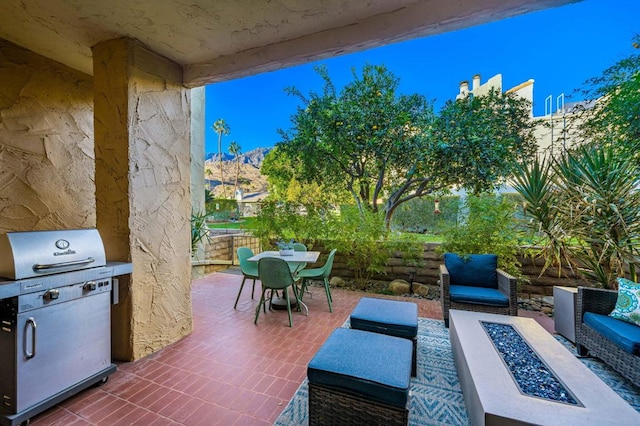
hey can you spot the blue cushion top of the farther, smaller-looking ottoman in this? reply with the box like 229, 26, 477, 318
350, 297, 418, 339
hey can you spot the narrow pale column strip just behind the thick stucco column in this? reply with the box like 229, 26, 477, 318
191, 86, 205, 262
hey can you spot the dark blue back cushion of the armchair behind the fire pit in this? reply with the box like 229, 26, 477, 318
444, 253, 498, 288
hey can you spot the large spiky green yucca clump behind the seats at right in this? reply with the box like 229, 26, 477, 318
514, 145, 640, 289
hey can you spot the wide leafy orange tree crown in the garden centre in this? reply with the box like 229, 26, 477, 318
267, 65, 535, 227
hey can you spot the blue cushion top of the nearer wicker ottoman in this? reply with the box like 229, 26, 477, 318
307, 328, 412, 408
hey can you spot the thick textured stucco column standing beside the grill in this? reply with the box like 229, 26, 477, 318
93, 39, 192, 360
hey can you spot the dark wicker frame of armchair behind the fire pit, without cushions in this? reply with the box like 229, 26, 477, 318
440, 253, 518, 328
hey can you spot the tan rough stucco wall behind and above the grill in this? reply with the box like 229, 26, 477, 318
0, 39, 96, 233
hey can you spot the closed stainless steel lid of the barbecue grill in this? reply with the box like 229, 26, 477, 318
0, 229, 106, 280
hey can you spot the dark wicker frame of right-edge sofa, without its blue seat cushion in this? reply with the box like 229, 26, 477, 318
576, 287, 640, 386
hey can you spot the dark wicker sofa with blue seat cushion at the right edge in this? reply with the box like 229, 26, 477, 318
576, 287, 640, 386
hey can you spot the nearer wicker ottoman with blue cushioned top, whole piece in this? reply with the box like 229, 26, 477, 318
307, 328, 412, 425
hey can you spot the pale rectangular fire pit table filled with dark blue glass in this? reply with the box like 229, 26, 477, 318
449, 310, 640, 425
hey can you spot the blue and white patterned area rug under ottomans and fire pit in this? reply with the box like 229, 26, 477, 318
275, 318, 640, 426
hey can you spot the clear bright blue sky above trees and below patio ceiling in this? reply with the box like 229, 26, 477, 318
205, 0, 640, 153
